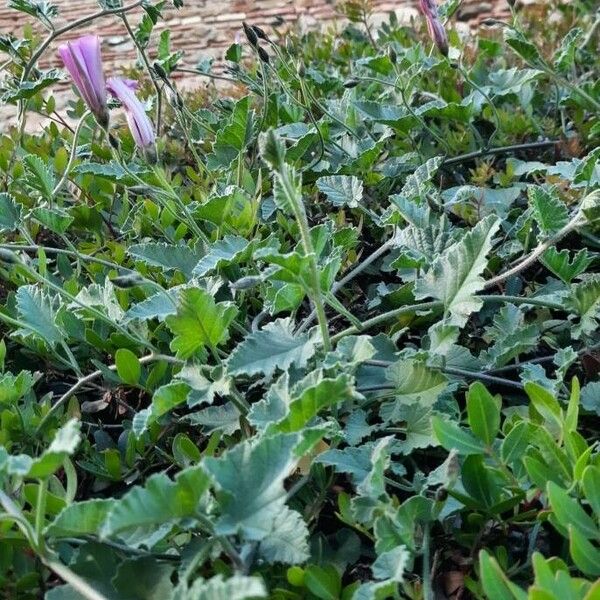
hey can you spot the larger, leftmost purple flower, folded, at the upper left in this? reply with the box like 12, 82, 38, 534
58, 35, 108, 127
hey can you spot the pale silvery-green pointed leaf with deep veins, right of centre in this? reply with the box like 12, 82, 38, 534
415, 216, 500, 327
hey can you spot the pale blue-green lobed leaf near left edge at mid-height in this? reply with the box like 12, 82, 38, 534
16, 285, 64, 348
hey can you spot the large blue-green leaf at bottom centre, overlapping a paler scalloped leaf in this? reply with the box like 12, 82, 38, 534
202, 434, 299, 541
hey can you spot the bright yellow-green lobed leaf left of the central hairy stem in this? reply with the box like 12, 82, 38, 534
165, 288, 237, 359
